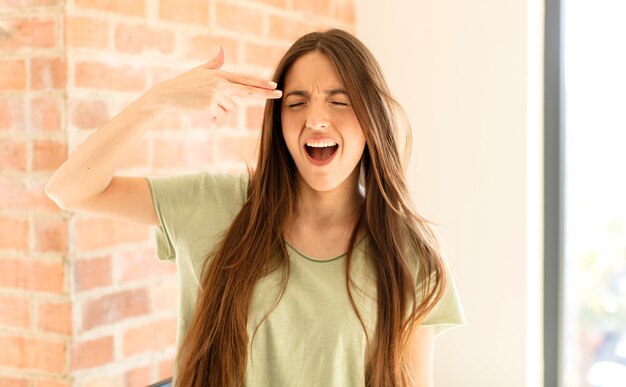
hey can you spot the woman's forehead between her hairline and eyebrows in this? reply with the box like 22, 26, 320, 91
285, 51, 344, 90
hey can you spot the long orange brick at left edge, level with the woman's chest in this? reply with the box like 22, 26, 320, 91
0, 259, 64, 292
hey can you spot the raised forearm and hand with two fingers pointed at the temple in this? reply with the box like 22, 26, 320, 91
46, 46, 282, 209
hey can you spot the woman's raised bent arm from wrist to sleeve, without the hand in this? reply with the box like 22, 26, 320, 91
46, 94, 161, 224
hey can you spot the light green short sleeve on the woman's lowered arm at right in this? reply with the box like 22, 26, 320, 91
422, 257, 466, 336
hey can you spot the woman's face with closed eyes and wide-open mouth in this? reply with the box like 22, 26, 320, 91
281, 51, 365, 191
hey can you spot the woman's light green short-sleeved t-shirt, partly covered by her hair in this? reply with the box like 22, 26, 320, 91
148, 172, 464, 387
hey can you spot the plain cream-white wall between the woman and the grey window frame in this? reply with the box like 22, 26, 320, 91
356, 0, 543, 387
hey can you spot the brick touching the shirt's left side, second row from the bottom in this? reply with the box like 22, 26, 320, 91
123, 319, 176, 357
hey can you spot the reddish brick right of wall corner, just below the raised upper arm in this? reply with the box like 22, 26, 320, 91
75, 218, 150, 251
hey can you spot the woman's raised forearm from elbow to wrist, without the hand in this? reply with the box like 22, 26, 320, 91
46, 93, 160, 208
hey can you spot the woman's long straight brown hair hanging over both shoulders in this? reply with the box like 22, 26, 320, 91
177, 29, 445, 387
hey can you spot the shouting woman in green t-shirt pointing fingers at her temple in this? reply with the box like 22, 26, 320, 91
46, 30, 463, 387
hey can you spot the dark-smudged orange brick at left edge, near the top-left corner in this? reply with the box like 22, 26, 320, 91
0, 18, 56, 51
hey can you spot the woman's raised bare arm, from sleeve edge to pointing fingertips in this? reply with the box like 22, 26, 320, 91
46, 48, 281, 225
